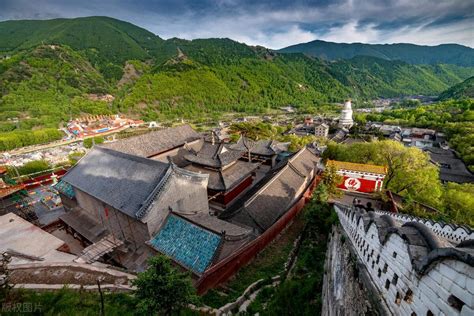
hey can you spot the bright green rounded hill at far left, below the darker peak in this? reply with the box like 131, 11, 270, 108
0, 45, 110, 131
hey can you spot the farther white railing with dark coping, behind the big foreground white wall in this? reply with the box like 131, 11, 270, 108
375, 211, 474, 244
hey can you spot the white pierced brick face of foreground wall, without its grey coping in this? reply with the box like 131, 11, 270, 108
335, 206, 474, 315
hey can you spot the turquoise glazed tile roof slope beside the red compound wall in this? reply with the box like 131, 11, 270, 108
150, 215, 221, 274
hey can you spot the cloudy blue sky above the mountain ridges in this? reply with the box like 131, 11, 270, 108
0, 0, 474, 49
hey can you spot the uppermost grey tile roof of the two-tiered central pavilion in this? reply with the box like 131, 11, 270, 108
184, 142, 243, 168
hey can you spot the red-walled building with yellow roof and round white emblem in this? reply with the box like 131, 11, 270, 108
326, 160, 387, 193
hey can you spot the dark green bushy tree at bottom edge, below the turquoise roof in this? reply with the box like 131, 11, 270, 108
133, 255, 197, 315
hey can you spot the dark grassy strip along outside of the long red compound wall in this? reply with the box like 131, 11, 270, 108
202, 214, 305, 308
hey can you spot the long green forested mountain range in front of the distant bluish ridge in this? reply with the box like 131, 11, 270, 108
0, 17, 474, 148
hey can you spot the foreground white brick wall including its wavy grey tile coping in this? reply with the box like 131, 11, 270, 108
334, 205, 474, 316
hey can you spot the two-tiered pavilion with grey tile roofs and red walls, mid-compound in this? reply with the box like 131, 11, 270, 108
184, 141, 258, 208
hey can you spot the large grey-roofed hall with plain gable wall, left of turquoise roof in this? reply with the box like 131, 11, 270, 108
56, 147, 209, 270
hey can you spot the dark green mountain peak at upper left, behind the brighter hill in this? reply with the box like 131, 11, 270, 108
0, 17, 163, 78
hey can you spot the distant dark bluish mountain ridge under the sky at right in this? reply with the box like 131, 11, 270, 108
279, 40, 474, 67
